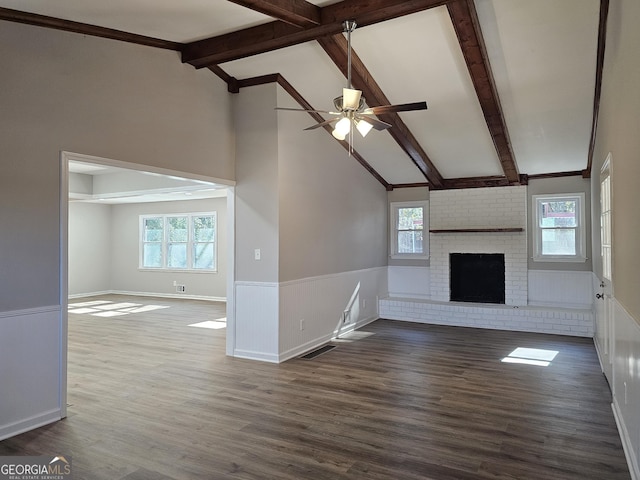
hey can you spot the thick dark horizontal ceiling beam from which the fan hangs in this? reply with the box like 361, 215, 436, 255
182, 0, 450, 68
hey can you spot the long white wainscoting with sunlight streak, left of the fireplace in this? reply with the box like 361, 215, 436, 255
279, 267, 388, 361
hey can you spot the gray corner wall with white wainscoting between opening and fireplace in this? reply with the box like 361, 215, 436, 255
231, 84, 387, 361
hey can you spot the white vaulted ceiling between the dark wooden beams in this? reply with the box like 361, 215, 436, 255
0, 0, 600, 190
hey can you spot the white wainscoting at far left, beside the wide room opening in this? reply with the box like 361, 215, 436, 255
0, 305, 63, 440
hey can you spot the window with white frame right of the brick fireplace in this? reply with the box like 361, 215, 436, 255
533, 193, 586, 262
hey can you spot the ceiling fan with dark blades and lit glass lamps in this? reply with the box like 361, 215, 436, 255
276, 21, 427, 151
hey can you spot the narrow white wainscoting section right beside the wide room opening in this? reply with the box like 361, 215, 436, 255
233, 281, 279, 363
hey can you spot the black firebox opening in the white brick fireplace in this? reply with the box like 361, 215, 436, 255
449, 253, 505, 303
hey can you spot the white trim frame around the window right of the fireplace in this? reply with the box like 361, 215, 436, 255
531, 193, 587, 263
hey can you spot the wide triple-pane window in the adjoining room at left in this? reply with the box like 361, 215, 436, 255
139, 212, 216, 272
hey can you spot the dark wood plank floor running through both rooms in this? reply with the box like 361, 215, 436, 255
0, 296, 630, 480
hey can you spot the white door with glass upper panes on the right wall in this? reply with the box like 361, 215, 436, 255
596, 154, 615, 385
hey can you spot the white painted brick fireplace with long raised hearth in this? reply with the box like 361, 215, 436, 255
379, 186, 593, 337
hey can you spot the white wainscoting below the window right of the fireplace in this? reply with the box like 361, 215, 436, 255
529, 270, 595, 309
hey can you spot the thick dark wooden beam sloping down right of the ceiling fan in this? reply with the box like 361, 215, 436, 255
447, 0, 520, 185
